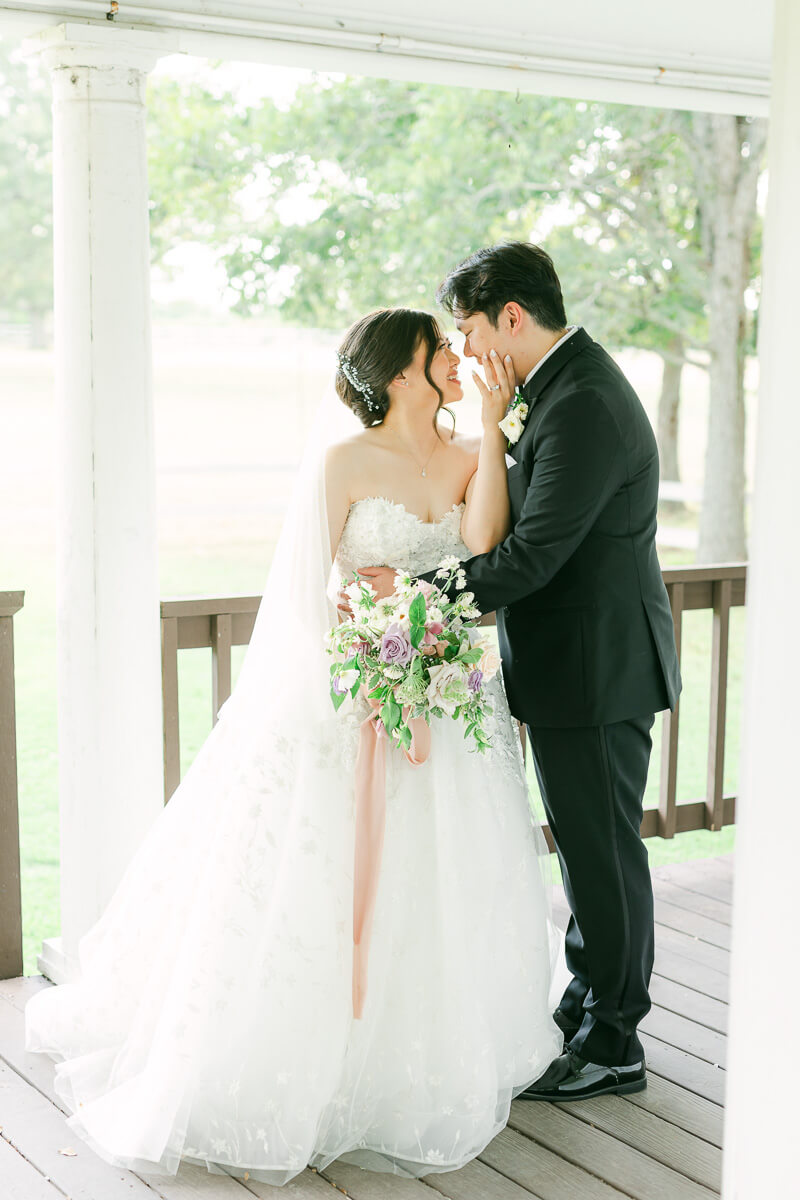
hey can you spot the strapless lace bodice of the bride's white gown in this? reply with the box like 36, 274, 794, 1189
336, 496, 469, 575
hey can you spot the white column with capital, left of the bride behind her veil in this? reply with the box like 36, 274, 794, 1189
28, 25, 174, 982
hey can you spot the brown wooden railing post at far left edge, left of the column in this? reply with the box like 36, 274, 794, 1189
0, 592, 25, 979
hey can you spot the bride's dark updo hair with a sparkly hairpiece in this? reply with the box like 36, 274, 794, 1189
336, 308, 450, 428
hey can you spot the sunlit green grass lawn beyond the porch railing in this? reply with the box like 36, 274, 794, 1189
0, 324, 744, 973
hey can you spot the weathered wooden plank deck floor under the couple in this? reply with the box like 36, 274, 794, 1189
0, 856, 733, 1200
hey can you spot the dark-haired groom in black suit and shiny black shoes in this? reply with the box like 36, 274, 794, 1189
365, 242, 681, 1100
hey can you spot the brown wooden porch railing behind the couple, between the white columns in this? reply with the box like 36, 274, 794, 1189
161, 563, 747, 850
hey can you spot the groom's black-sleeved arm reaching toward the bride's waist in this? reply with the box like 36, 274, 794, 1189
421, 391, 626, 612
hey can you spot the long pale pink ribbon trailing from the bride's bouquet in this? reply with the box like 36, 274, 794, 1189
353, 700, 431, 1020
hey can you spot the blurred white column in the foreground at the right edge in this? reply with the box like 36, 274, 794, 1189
722, 0, 800, 1200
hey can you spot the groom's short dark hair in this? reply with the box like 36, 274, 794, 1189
437, 241, 566, 331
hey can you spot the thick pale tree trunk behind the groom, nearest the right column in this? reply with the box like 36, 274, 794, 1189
696, 114, 765, 563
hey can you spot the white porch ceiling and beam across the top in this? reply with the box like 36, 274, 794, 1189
0, 0, 772, 114
